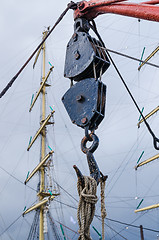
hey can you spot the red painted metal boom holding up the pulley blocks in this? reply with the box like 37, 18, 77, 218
74, 0, 159, 22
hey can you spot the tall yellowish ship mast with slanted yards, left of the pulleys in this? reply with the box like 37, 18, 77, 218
23, 29, 58, 240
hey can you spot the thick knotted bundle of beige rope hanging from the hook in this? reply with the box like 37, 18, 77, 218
77, 176, 98, 240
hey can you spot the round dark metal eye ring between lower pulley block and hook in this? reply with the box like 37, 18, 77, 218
81, 133, 99, 154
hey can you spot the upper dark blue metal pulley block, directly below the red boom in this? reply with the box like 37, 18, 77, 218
64, 19, 110, 81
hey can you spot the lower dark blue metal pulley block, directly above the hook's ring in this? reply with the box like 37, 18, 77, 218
62, 78, 106, 130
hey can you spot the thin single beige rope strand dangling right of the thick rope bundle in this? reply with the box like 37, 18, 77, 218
100, 179, 107, 240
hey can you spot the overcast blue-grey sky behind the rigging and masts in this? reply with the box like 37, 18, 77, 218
0, 0, 159, 240
